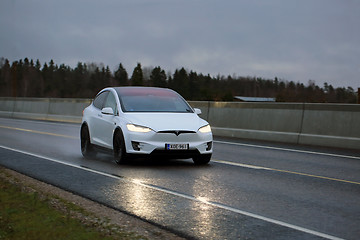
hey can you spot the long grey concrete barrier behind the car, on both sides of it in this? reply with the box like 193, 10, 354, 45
0, 98, 360, 150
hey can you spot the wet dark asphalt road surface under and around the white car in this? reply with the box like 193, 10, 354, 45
0, 118, 360, 239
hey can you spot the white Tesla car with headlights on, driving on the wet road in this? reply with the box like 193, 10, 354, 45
80, 87, 213, 164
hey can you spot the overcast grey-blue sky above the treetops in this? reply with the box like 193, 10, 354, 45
0, 0, 360, 89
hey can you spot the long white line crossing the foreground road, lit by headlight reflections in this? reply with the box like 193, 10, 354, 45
0, 145, 342, 240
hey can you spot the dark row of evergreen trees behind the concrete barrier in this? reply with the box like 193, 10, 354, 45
0, 58, 357, 103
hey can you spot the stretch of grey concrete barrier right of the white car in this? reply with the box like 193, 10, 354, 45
190, 102, 360, 150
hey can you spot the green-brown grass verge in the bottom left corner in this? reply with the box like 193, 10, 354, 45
0, 172, 146, 240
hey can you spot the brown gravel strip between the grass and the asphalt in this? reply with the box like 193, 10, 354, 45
0, 166, 184, 240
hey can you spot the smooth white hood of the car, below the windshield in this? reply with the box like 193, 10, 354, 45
126, 113, 208, 132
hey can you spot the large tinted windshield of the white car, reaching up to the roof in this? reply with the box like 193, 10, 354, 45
116, 87, 193, 113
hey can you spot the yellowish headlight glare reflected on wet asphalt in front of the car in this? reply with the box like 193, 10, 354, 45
108, 178, 222, 238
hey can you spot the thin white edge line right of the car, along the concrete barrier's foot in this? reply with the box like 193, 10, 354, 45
214, 141, 360, 160
